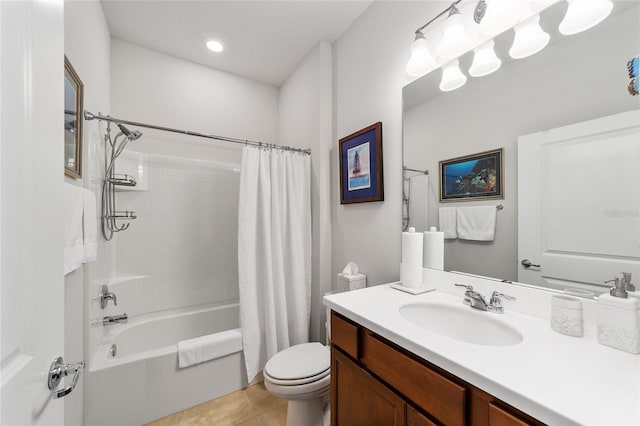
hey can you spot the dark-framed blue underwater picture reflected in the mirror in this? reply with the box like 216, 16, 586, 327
440, 148, 504, 201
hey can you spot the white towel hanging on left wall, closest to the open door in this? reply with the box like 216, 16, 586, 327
64, 183, 84, 275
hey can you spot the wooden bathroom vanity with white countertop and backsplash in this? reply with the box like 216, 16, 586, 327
324, 270, 640, 426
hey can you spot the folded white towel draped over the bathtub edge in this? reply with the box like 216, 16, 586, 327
178, 328, 242, 368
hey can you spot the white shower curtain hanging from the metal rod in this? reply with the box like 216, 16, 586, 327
238, 146, 311, 381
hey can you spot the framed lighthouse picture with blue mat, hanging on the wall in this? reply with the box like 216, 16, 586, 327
339, 122, 384, 204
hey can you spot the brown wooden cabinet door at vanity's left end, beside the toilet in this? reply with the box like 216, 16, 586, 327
331, 348, 407, 426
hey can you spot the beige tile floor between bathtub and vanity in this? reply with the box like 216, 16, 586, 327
146, 383, 287, 426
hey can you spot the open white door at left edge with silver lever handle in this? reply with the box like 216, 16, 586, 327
0, 0, 68, 425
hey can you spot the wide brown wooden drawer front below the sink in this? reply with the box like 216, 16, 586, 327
360, 332, 467, 425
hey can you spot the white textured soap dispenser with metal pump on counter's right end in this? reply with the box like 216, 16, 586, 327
598, 276, 640, 354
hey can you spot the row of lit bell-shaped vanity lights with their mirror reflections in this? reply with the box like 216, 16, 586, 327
406, 0, 613, 91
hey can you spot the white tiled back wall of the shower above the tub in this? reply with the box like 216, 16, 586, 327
91, 147, 240, 362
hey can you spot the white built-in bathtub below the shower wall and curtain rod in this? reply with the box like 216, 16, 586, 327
84, 303, 247, 426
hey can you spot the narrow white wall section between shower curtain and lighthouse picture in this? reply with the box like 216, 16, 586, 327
278, 42, 332, 341
